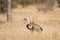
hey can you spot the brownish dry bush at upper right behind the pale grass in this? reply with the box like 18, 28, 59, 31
37, 0, 57, 12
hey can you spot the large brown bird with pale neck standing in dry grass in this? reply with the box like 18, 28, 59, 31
24, 18, 43, 32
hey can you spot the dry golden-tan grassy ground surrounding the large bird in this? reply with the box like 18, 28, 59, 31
0, 6, 60, 40
